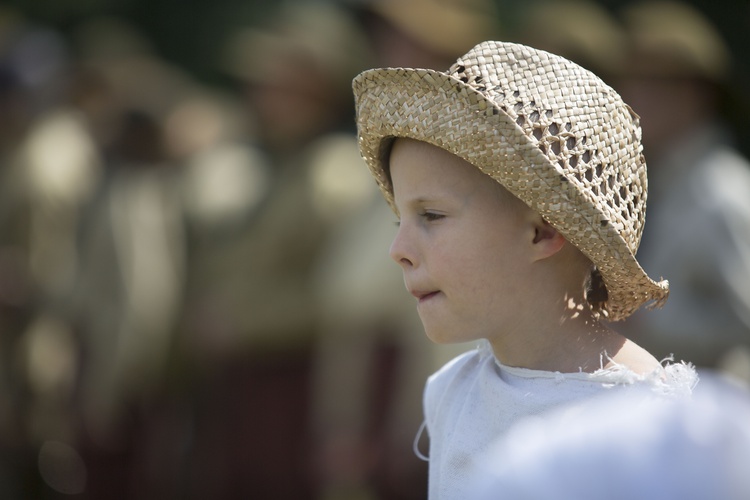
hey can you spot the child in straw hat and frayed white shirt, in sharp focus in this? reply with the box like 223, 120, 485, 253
353, 42, 696, 498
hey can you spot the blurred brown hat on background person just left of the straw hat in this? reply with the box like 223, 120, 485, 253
224, 2, 371, 86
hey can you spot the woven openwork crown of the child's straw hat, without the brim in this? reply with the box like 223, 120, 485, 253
448, 42, 647, 254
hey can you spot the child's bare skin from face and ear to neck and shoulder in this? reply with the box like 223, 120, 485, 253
389, 139, 660, 373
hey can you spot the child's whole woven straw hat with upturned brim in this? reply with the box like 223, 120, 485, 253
353, 42, 669, 321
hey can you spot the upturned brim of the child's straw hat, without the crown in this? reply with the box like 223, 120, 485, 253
353, 68, 669, 321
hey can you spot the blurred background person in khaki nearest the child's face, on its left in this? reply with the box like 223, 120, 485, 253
175, 2, 368, 499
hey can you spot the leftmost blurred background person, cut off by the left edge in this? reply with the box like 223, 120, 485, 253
0, 9, 101, 498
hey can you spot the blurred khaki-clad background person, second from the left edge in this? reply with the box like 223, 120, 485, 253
63, 18, 201, 498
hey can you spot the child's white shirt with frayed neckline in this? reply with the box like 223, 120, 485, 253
424, 343, 697, 500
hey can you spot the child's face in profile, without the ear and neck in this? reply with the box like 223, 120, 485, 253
390, 139, 534, 343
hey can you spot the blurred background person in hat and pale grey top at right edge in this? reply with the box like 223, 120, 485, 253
619, 1, 750, 381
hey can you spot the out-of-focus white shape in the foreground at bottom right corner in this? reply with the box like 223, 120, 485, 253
466, 372, 750, 500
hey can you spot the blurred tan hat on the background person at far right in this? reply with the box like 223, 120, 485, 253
621, 1, 731, 83
